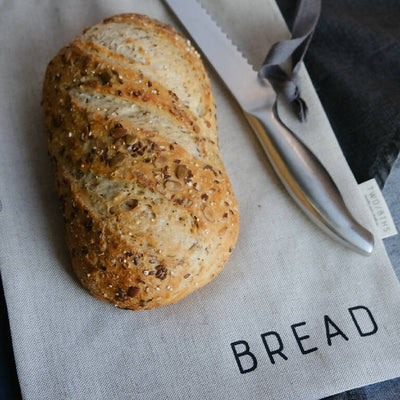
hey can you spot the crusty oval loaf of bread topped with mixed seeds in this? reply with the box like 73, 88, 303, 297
43, 14, 239, 310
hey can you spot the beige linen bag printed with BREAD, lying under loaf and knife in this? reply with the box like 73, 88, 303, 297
0, 0, 400, 400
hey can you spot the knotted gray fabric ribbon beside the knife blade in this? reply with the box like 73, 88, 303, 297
259, 0, 321, 122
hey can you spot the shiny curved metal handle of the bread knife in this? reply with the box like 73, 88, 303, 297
245, 103, 374, 255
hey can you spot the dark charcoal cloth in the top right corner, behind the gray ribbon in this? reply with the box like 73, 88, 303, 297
277, 0, 400, 187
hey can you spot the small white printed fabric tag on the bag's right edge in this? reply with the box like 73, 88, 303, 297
358, 178, 398, 239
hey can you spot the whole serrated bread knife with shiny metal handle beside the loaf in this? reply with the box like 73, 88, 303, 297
166, 0, 374, 255
